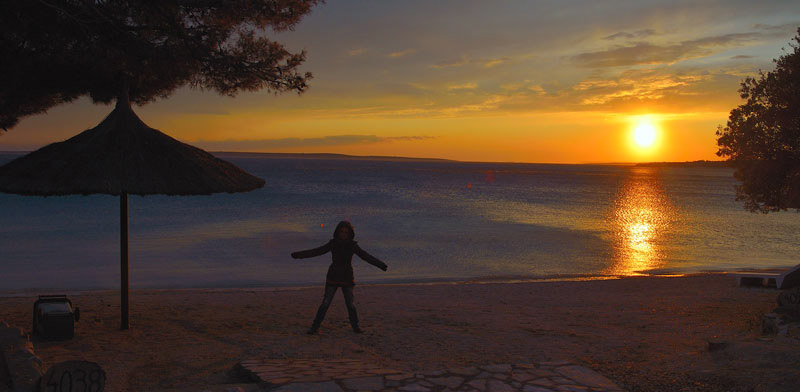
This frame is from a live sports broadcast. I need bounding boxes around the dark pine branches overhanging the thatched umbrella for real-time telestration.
[0,0,322,130]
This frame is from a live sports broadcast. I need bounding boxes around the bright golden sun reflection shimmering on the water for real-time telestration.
[607,167,676,275]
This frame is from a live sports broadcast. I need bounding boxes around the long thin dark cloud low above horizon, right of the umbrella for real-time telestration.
[194,135,435,151]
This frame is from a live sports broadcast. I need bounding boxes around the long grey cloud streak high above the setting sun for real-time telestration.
[572,32,764,68]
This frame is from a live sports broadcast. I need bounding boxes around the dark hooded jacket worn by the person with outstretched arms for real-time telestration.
[292,222,387,286]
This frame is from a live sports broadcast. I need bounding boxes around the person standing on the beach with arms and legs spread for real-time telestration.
[292,221,389,335]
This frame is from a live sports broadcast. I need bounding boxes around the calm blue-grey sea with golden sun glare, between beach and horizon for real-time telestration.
[0,156,800,290]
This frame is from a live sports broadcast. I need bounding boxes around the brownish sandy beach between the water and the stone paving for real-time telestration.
[0,275,800,391]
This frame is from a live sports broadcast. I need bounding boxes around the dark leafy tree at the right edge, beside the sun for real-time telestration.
[717,28,800,213]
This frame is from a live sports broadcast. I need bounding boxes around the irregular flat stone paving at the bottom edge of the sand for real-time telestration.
[240,360,622,392]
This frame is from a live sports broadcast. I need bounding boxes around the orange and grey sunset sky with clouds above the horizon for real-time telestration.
[0,0,800,163]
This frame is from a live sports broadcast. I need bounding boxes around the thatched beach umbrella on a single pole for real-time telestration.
[0,100,264,329]
